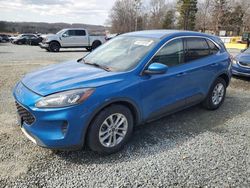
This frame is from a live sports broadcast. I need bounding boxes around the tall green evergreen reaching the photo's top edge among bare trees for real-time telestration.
[177,0,198,30]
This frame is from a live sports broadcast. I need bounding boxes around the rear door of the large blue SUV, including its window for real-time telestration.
[184,37,219,103]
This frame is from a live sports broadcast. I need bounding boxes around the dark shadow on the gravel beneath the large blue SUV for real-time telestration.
[55,93,250,164]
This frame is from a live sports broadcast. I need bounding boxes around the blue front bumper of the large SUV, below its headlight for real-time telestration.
[13,83,96,150]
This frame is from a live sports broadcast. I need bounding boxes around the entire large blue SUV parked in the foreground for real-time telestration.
[13,30,231,154]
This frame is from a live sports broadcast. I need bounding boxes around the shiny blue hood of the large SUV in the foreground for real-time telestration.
[22,61,122,96]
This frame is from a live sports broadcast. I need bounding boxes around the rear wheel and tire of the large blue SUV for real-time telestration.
[202,77,227,110]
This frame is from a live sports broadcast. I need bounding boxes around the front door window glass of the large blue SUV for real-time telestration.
[151,39,184,67]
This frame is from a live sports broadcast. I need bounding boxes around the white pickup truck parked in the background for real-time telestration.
[39,28,106,52]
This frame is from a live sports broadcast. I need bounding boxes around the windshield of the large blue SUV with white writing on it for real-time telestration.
[83,36,158,71]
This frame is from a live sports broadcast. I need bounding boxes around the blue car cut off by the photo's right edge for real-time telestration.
[232,48,250,77]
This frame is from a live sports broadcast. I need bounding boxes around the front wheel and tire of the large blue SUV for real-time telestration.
[87,105,134,154]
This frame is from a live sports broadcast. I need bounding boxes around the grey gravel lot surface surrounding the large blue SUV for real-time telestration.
[0,44,250,187]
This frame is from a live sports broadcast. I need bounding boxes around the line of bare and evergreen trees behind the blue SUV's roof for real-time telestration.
[107,0,250,35]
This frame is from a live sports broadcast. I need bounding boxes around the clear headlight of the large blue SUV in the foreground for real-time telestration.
[36,88,94,108]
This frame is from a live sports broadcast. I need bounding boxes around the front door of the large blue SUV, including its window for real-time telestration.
[141,39,196,119]
